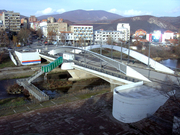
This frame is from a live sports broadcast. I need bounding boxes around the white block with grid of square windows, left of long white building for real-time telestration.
[69,25,93,45]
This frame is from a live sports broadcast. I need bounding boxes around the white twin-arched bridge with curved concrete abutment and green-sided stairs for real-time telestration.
[15,45,177,123]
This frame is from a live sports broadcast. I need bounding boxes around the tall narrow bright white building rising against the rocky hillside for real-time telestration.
[117,23,130,41]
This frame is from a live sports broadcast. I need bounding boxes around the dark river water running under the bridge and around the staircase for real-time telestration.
[0,72,110,99]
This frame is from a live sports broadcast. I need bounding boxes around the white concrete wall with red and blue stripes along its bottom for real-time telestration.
[15,51,41,65]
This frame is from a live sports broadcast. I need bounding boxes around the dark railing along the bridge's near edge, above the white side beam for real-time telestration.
[74,60,140,82]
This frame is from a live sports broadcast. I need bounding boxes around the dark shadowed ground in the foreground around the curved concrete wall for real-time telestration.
[0,92,180,135]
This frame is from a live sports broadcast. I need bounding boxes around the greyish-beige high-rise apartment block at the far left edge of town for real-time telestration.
[2,11,21,32]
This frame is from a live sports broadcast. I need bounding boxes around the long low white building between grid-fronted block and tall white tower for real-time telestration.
[94,29,125,44]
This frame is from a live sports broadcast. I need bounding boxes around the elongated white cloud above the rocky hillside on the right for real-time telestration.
[109,8,151,16]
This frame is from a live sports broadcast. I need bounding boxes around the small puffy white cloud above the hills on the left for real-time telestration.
[35,7,65,15]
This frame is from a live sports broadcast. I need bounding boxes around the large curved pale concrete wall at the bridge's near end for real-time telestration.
[112,82,168,123]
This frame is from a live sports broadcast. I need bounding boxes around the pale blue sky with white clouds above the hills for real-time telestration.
[0,0,180,17]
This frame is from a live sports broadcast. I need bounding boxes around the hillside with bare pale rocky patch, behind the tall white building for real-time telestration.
[90,16,178,33]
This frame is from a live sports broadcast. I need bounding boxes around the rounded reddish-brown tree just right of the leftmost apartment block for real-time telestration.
[18,28,30,44]
